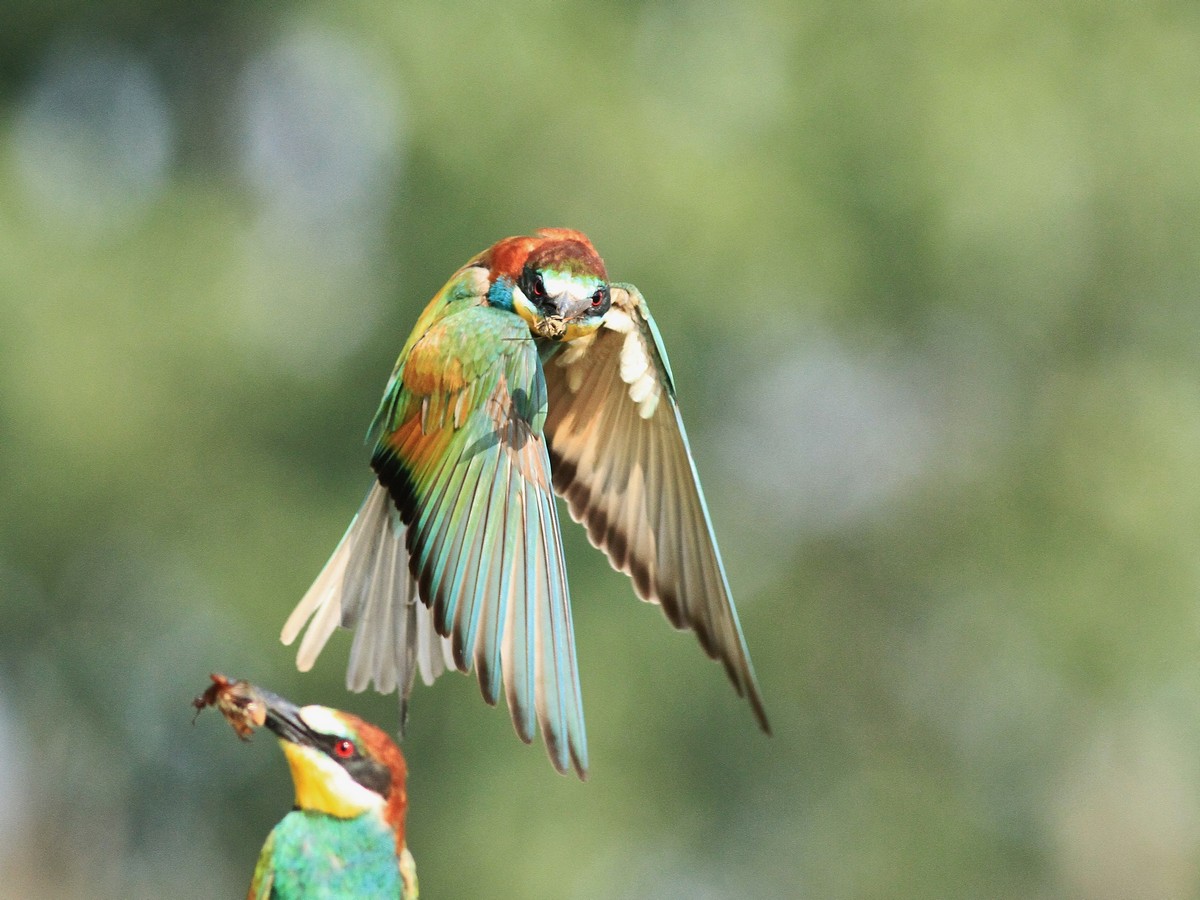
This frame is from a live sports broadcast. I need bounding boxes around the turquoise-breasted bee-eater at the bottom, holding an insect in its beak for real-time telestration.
[196,674,418,900]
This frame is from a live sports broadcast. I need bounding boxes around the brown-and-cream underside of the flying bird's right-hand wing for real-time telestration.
[546,284,770,733]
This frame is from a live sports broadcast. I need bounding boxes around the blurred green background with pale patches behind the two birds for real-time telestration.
[0,0,1200,900]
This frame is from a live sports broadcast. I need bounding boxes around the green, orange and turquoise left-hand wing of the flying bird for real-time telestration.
[372,306,587,775]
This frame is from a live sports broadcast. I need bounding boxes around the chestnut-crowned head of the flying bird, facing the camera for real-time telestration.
[472,228,612,341]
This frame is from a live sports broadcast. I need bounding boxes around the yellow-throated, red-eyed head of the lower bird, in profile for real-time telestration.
[260,691,408,850]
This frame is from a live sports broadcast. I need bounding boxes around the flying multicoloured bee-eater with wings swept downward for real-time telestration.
[282,228,770,778]
